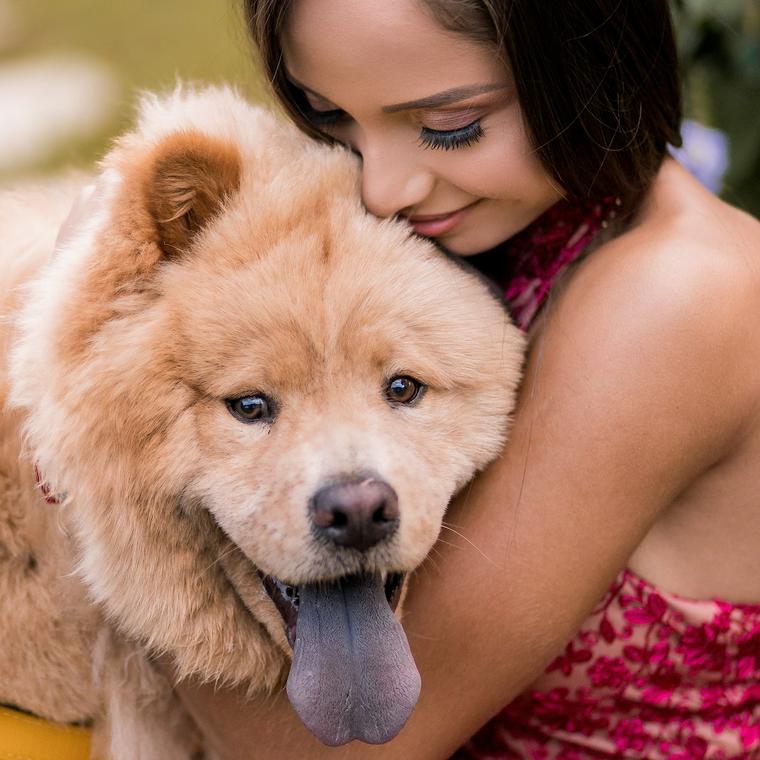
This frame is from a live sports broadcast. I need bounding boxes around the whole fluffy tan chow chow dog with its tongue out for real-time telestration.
[0,88,524,760]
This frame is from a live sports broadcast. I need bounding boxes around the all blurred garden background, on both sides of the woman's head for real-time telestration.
[0,0,760,216]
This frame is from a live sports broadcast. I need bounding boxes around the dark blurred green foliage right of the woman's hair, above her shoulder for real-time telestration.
[676,0,760,216]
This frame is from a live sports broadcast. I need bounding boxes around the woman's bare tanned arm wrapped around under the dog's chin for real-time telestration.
[171,227,754,760]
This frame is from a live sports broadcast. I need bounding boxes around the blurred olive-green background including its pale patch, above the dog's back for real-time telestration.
[0,0,265,182]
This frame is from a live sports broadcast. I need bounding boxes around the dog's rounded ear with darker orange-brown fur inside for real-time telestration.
[143,131,241,256]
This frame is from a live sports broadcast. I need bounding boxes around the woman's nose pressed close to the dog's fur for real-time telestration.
[360,142,435,218]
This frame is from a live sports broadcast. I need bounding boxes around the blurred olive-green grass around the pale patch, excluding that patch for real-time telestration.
[0,0,265,171]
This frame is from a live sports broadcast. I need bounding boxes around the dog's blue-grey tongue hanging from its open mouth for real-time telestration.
[287,576,420,747]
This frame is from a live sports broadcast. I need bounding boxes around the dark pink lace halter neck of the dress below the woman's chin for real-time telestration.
[500,196,621,330]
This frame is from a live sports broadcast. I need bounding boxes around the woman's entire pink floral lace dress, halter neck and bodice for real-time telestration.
[452,199,760,760]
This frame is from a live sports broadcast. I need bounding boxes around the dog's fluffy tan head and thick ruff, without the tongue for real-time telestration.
[13,90,523,744]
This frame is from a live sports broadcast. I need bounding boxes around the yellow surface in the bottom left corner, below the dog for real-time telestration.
[0,707,91,760]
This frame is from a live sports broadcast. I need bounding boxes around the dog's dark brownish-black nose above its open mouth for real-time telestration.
[310,478,399,551]
